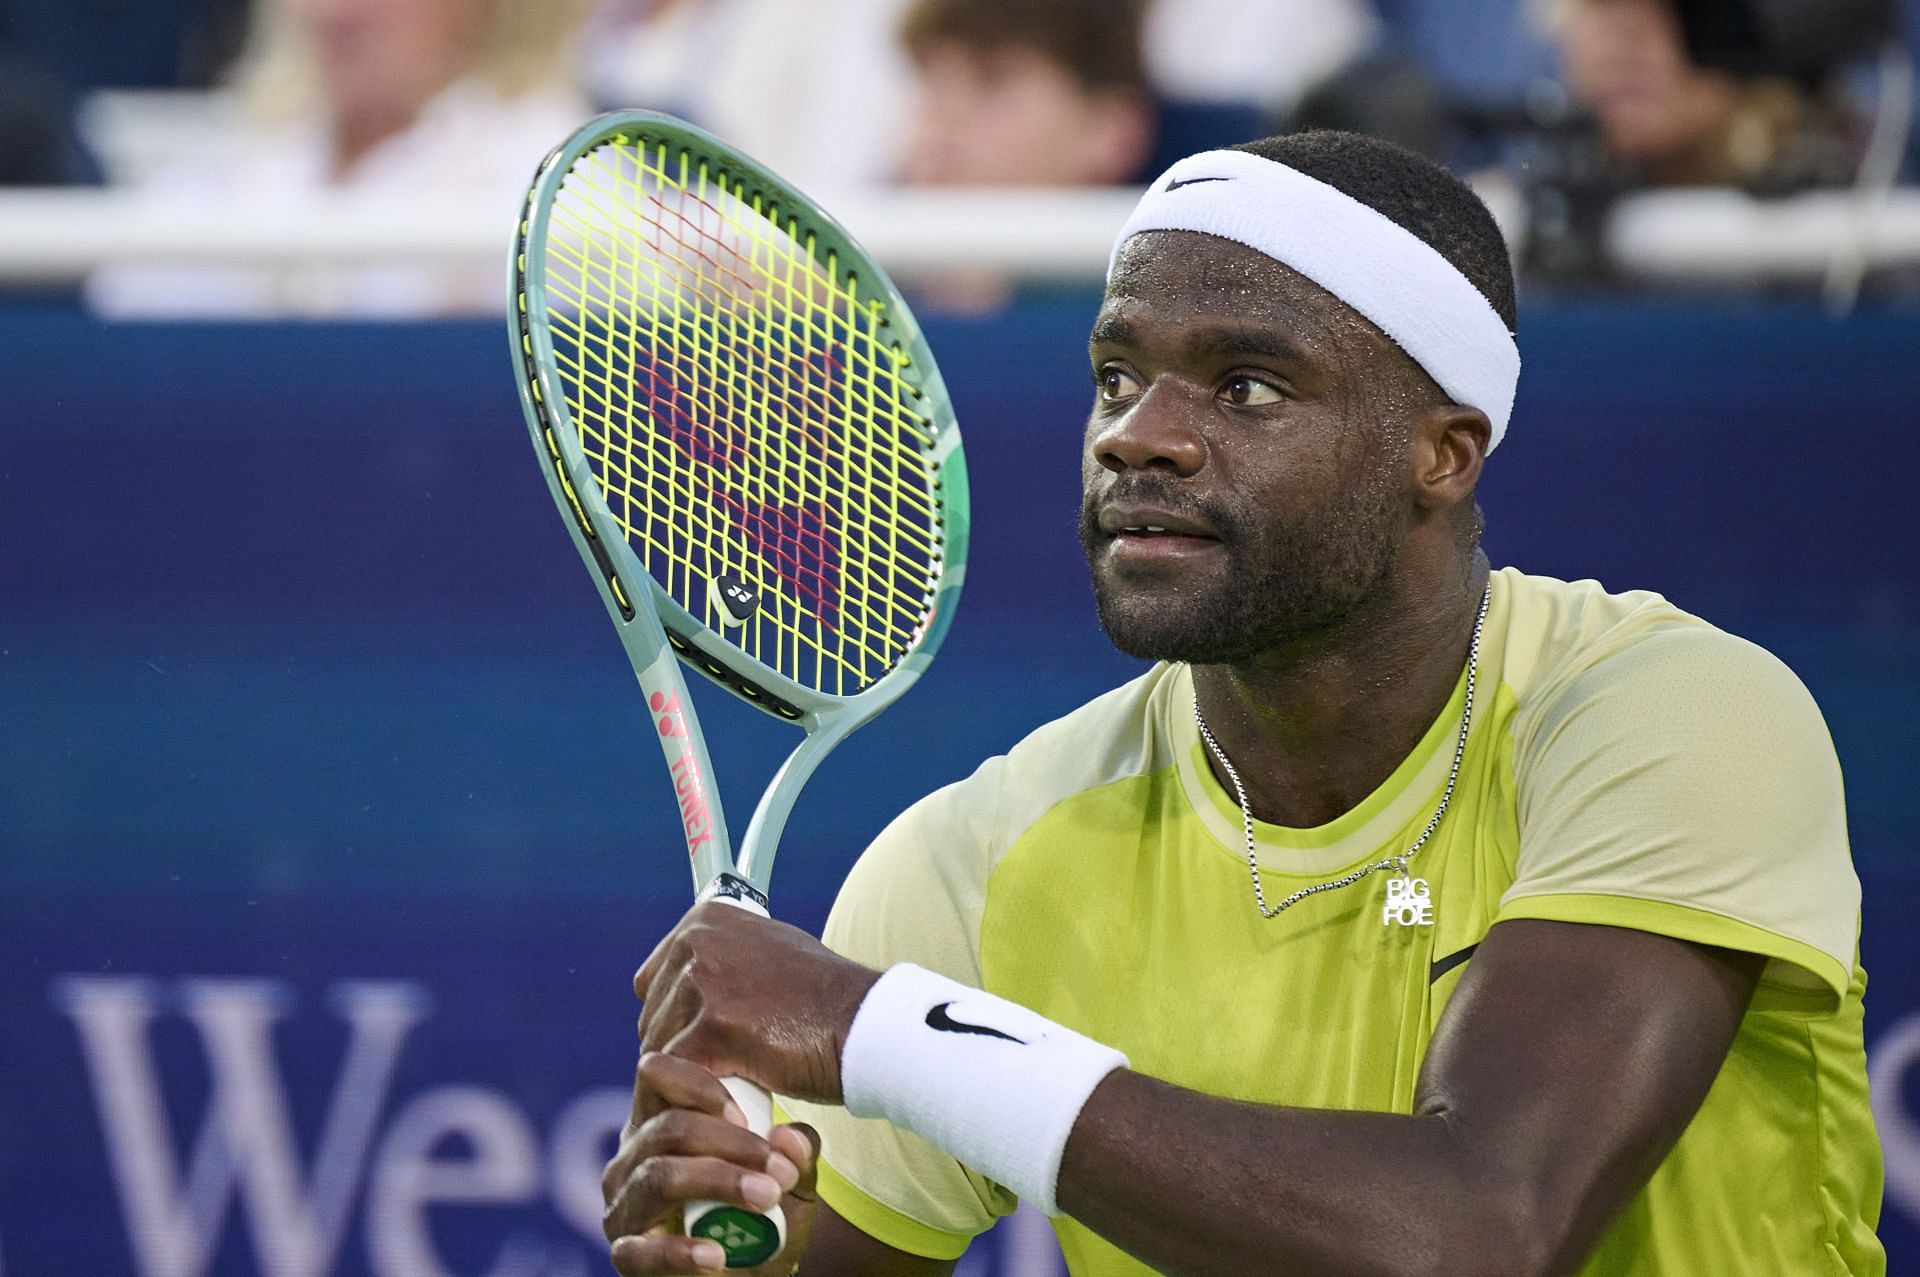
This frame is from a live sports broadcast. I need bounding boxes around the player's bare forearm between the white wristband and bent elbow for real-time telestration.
[1060,1072,1569,1277]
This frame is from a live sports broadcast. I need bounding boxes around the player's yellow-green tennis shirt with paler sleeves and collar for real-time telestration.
[787,568,1885,1277]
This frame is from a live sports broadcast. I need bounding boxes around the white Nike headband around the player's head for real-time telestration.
[1108,152,1521,451]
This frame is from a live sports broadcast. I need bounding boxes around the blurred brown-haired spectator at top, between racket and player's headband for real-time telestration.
[900,0,1154,186]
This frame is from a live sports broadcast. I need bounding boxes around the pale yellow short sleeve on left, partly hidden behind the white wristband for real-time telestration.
[781,759,1016,1260]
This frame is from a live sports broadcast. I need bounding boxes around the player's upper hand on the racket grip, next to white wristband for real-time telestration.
[634,903,879,1104]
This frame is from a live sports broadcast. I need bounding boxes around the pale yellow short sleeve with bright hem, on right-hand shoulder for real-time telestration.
[1500,624,1860,1010]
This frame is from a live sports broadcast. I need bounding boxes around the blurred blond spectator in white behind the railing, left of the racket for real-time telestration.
[88,0,589,317]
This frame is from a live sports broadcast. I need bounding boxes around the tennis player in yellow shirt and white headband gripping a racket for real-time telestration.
[607,134,1885,1277]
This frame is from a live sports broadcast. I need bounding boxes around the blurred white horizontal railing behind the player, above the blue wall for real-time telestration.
[0,188,1920,288]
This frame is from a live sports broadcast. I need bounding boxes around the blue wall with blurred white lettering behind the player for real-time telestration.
[0,298,1920,1277]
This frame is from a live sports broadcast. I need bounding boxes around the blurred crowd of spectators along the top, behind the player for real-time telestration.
[0,0,1920,317]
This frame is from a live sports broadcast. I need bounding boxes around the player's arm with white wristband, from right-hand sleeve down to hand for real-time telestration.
[636,904,1766,1277]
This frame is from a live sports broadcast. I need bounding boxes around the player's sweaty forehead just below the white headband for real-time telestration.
[1100,230,1405,361]
